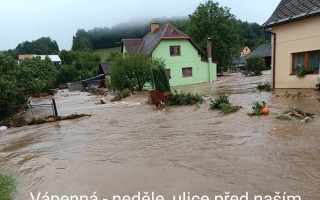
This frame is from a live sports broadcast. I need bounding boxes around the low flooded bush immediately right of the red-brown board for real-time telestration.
[167,90,203,105]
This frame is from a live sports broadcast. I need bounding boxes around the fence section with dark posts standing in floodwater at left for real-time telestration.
[27,99,58,118]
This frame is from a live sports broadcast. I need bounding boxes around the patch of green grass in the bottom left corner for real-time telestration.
[0,174,16,200]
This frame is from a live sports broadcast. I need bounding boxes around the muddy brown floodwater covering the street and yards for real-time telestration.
[0,73,320,200]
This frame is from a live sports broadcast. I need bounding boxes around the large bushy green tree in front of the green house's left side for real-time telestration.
[111,54,153,91]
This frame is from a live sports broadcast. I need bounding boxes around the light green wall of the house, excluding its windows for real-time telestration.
[152,40,217,86]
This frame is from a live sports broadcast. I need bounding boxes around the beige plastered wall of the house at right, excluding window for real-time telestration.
[272,16,320,88]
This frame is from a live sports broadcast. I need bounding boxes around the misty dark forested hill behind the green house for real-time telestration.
[72,17,270,51]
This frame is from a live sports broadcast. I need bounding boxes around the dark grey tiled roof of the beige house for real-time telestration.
[262,0,320,28]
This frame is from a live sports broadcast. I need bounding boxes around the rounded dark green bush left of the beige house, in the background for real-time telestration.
[245,56,266,76]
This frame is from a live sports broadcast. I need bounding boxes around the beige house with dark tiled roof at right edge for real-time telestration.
[262,0,320,88]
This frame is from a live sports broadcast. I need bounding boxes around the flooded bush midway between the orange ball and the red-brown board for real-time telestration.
[209,94,241,115]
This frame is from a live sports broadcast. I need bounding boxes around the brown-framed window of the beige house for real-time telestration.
[292,50,320,73]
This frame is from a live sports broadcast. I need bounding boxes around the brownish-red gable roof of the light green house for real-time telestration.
[122,23,204,54]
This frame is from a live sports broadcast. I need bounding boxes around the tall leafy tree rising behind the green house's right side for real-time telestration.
[188,0,242,73]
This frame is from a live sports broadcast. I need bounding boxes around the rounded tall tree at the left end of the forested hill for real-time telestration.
[72,29,93,51]
